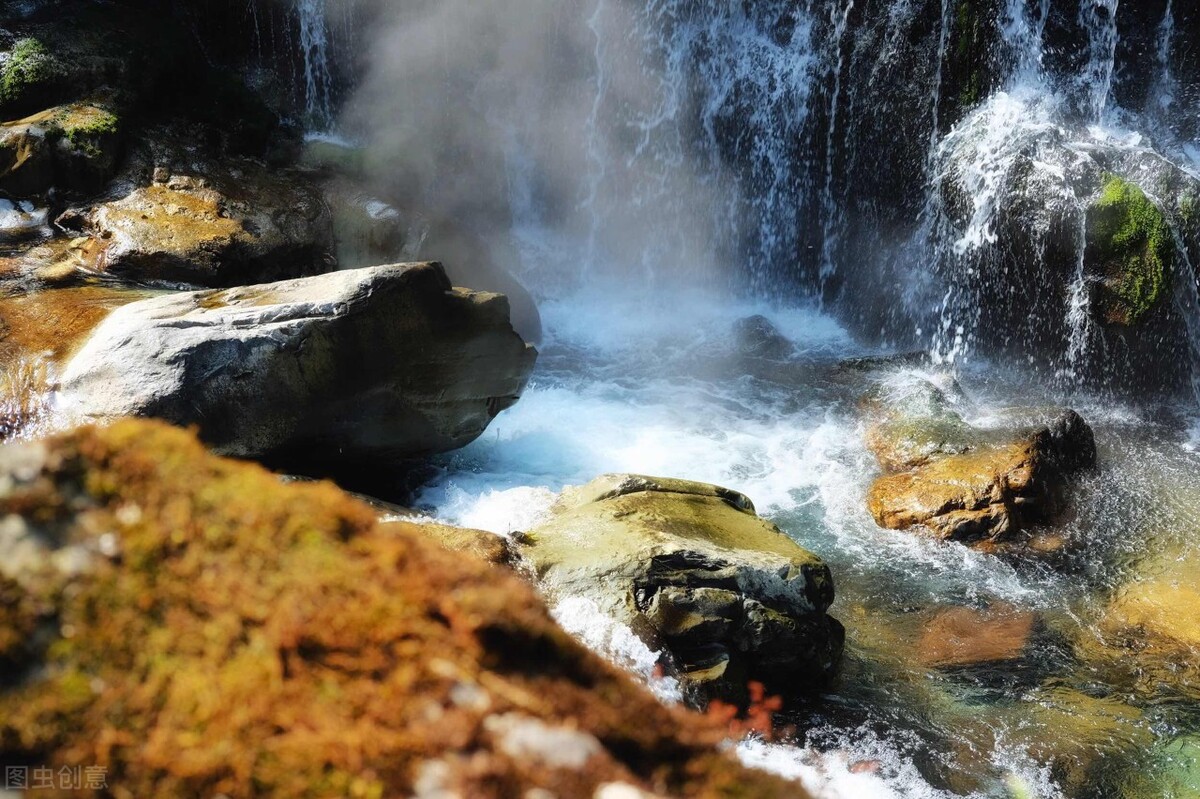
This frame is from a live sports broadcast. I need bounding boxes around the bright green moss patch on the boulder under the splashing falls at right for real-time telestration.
[1087,175,1175,325]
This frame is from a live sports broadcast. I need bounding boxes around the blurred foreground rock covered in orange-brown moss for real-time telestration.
[0,421,805,798]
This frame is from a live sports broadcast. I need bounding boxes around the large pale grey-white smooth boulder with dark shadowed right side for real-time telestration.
[58,263,536,470]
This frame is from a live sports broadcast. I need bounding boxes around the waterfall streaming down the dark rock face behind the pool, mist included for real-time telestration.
[343,0,1200,395]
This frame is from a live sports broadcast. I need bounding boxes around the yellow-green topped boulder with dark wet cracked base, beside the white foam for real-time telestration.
[518,475,844,692]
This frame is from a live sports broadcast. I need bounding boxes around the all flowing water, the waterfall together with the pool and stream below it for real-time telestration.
[333,0,1200,798]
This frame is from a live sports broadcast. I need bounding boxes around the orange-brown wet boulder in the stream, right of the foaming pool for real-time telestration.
[866,378,1096,549]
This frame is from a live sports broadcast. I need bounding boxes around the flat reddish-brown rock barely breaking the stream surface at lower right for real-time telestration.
[917,605,1037,669]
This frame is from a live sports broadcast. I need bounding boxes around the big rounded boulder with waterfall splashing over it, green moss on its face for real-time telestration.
[937,94,1200,392]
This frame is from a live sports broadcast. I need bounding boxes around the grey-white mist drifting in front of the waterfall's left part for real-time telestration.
[340,0,738,298]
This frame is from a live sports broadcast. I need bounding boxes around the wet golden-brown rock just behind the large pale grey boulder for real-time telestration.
[70,161,332,287]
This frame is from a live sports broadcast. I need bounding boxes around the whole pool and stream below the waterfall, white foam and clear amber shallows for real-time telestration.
[418,287,1200,797]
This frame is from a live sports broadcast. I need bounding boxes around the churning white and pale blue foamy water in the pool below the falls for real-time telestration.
[418,272,1183,798]
